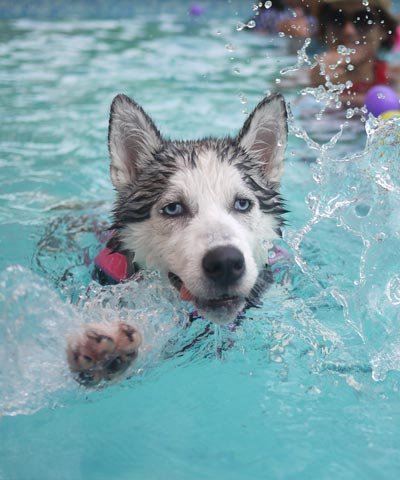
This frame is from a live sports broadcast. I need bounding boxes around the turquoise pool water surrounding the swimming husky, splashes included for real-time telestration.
[0,1,400,480]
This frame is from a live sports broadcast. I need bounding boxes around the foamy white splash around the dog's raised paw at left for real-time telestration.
[0,266,187,415]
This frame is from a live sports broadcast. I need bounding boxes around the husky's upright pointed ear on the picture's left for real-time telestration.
[108,94,162,190]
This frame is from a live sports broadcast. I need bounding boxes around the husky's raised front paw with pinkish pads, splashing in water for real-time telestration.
[67,322,142,387]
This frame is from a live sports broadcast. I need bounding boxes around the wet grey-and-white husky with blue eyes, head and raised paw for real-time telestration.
[67,94,287,385]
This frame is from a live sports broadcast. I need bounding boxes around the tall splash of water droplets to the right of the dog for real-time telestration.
[287,110,400,379]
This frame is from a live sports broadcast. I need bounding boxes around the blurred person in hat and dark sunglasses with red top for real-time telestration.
[311,0,397,107]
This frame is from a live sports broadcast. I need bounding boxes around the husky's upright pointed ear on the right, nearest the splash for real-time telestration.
[237,94,288,183]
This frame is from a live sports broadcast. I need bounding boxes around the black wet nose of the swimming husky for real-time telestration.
[203,245,246,286]
